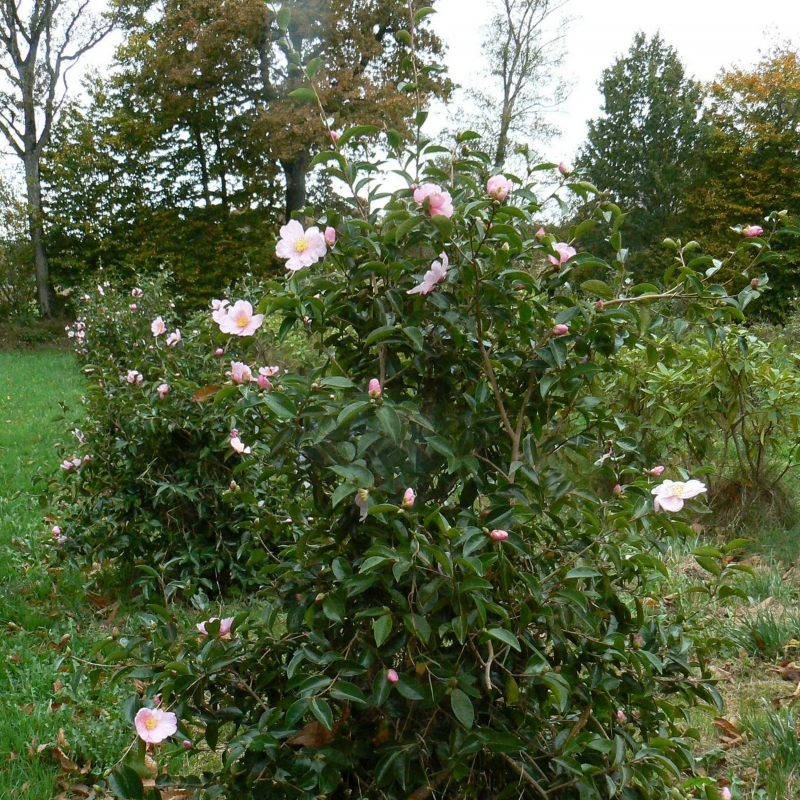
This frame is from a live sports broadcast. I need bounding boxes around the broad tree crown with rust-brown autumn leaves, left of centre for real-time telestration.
[112,0,448,216]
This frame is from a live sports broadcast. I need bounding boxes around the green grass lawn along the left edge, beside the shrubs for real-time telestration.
[0,351,130,800]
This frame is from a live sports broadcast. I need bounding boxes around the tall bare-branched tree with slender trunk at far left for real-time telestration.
[0,0,111,316]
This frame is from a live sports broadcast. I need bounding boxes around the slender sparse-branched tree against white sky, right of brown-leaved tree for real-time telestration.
[459,0,568,168]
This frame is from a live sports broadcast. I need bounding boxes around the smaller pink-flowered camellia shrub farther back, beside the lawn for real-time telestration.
[49,277,313,602]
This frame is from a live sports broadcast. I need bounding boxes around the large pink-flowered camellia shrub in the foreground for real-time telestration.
[76,112,788,800]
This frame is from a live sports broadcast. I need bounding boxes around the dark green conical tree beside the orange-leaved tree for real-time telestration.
[578,33,701,268]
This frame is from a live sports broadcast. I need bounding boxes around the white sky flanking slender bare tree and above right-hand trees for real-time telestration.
[432,0,800,163]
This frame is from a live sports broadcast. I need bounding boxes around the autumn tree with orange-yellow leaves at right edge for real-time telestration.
[679,45,800,320]
